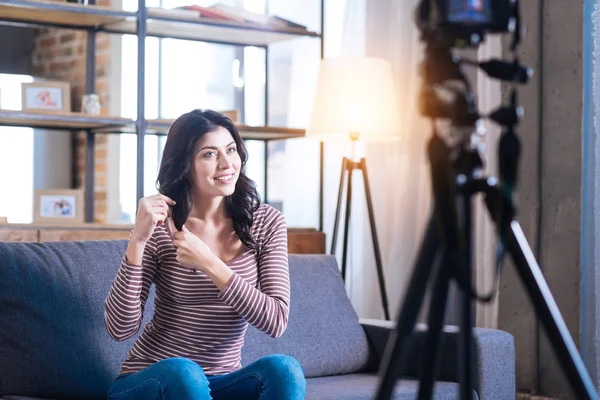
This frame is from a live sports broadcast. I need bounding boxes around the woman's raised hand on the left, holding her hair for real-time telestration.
[131,194,175,244]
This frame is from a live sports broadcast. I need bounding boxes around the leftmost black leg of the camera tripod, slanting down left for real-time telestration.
[375,216,441,400]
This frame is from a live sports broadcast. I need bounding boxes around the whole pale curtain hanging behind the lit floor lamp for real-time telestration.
[324,0,430,318]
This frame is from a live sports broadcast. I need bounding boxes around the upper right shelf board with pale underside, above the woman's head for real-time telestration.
[104,8,320,46]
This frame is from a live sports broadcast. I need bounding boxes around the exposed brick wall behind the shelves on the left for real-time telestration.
[33,0,110,222]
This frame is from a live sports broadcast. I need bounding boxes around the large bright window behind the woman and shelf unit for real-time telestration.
[119,0,320,227]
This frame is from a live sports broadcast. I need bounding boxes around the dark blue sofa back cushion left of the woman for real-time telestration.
[0,241,153,398]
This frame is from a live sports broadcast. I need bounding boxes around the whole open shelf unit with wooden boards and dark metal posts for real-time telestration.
[0,0,324,229]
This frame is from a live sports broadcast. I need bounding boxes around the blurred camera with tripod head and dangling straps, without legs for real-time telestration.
[415,0,533,142]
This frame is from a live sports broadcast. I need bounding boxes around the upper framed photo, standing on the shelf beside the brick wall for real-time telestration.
[21,81,71,113]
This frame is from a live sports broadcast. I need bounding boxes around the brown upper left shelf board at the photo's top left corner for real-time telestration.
[0,0,136,28]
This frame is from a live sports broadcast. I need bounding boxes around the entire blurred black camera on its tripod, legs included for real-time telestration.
[375,0,598,400]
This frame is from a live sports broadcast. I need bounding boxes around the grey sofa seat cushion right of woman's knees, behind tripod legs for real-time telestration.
[305,374,479,400]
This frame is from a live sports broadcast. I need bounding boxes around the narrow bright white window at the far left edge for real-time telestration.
[0,74,34,223]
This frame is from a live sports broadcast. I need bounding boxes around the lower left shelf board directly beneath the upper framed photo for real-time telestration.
[0,110,133,132]
